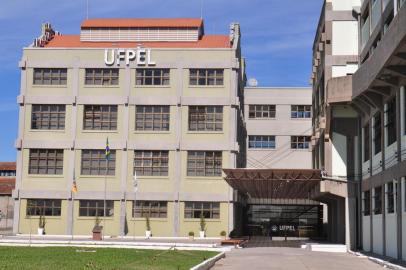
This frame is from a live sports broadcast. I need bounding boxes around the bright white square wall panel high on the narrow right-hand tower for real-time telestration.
[332,21,358,55]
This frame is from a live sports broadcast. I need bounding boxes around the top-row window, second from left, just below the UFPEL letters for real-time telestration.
[85,68,119,85]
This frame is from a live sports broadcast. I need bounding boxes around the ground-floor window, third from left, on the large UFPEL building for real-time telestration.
[133,201,168,218]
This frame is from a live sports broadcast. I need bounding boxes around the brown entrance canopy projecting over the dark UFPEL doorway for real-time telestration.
[223,169,321,199]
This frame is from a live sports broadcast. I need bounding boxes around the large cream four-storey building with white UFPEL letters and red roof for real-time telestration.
[13,19,245,237]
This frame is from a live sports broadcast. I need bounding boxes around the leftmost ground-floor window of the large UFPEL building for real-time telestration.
[26,199,61,216]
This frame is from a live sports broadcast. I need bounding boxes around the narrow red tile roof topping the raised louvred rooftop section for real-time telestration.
[81,18,203,28]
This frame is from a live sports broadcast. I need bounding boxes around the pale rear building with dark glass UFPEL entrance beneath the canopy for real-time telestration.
[242,87,323,237]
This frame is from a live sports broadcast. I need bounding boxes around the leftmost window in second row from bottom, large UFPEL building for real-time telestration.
[28,149,63,175]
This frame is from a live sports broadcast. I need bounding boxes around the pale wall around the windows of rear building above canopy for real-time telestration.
[244,87,312,169]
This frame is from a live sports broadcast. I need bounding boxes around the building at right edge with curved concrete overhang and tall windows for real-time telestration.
[352,0,406,261]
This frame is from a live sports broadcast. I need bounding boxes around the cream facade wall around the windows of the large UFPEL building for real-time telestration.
[15,25,244,236]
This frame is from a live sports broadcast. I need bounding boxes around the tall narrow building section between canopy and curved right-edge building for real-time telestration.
[310,0,361,247]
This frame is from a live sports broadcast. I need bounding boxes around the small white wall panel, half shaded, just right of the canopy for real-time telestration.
[331,132,347,176]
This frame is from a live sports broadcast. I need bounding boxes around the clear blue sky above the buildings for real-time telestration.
[0,0,323,161]
